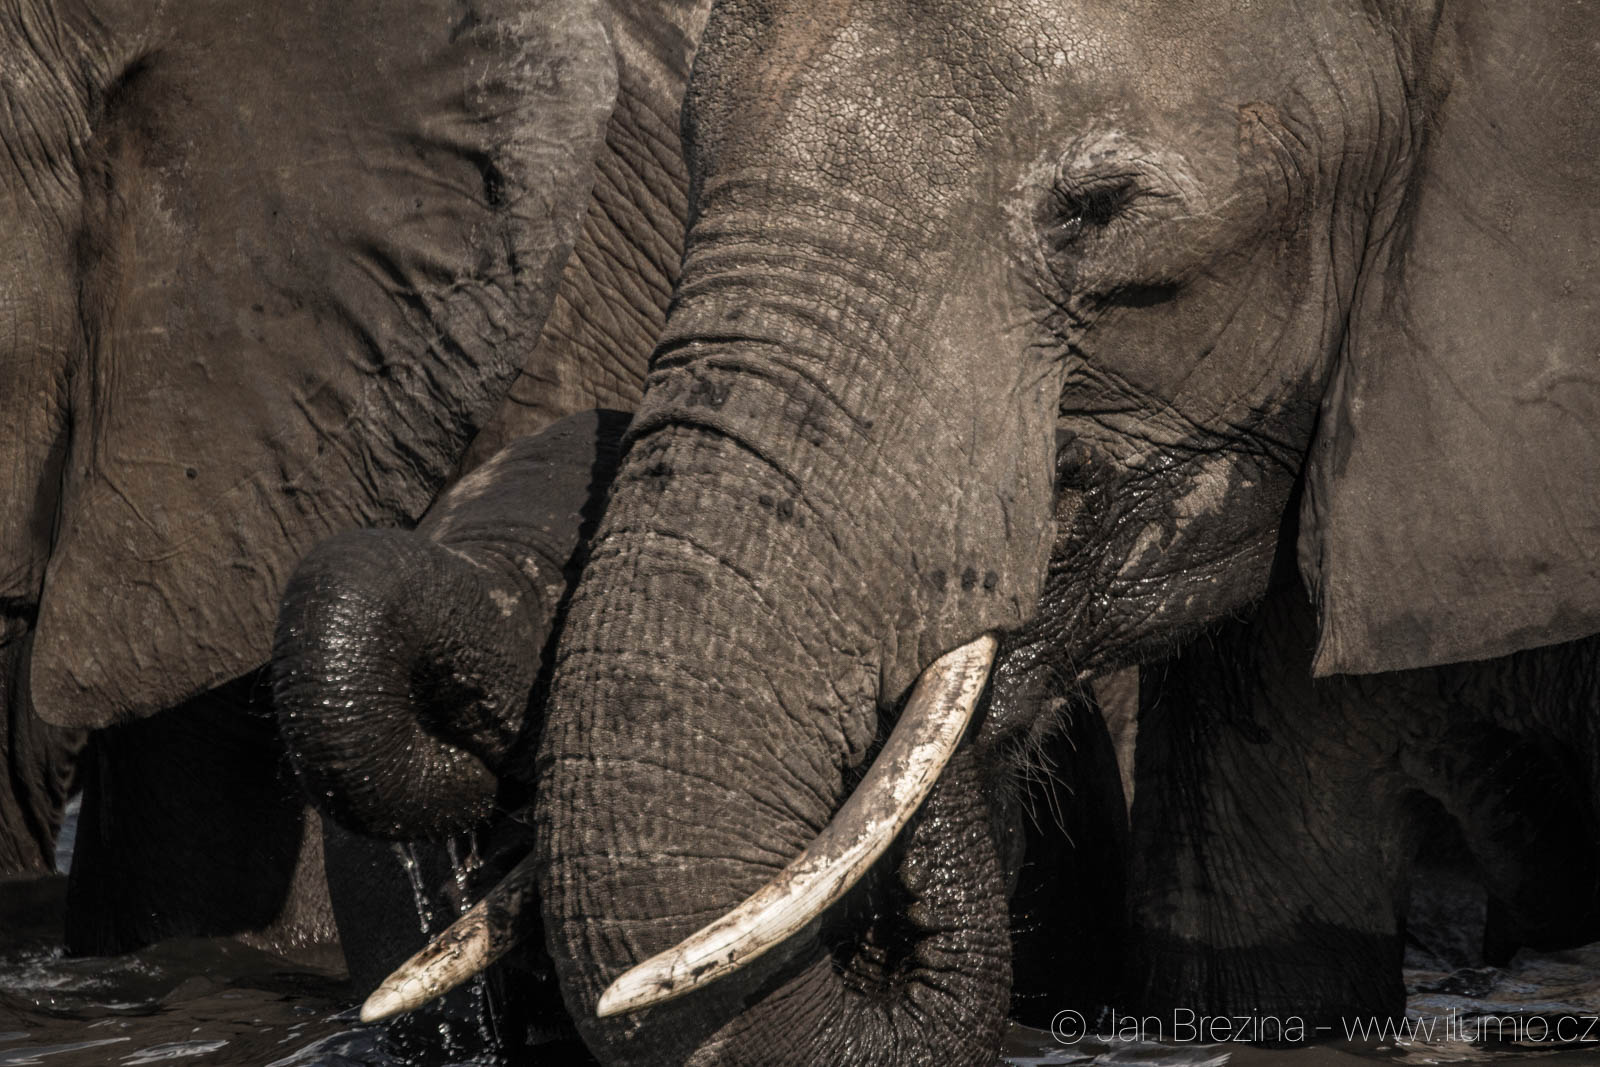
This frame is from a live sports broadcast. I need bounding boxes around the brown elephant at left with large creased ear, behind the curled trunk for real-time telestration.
[0,0,704,968]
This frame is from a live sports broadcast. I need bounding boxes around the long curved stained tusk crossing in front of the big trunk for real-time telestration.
[595,635,995,1017]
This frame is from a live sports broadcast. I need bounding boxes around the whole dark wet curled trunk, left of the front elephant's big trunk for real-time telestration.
[272,411,627,840]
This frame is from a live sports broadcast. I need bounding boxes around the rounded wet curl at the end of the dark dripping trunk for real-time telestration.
[272,530,549,840]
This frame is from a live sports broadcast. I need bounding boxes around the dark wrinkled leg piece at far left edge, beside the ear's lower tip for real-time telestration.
[0,641,86,878]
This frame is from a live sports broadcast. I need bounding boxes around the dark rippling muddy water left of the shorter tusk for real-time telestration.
[0,808,510,1067]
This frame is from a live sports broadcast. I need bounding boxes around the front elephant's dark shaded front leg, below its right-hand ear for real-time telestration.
[1128,585,1414,1040]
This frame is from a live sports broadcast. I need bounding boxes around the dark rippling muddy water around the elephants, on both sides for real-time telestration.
[9,806,1600,1067]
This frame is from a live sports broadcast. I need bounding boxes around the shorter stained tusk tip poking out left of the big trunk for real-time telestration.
[362,856,534,1022]
